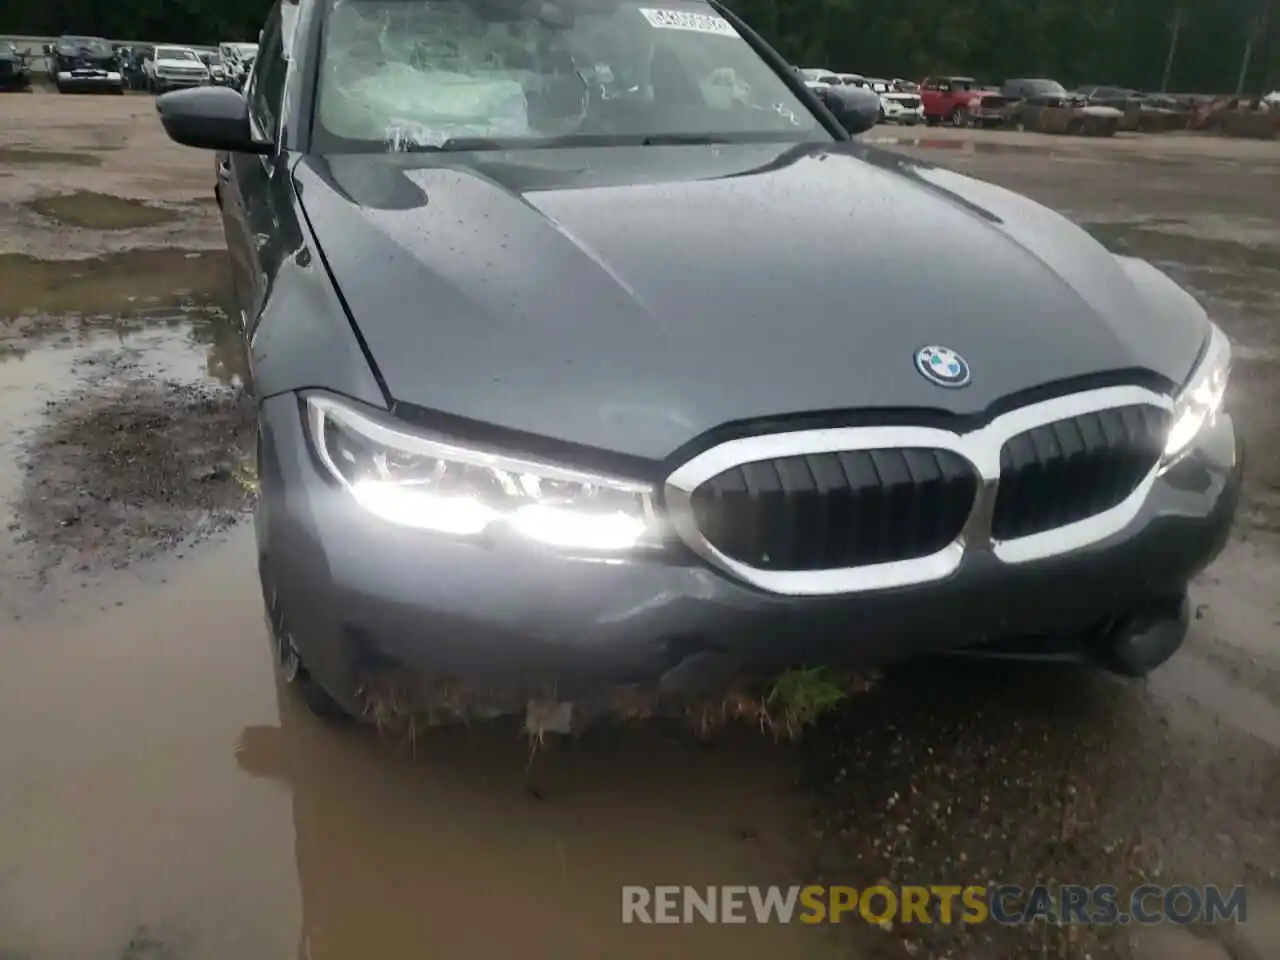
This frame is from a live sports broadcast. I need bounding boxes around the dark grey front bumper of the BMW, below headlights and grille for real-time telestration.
[256,396,1243,707]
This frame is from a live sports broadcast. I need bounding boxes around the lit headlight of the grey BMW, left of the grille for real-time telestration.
[306,396,662,552]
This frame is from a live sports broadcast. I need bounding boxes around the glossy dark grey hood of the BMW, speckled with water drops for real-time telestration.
[293,142,1204,460]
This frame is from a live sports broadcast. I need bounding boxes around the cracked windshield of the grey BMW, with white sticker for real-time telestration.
[315,0,831,152]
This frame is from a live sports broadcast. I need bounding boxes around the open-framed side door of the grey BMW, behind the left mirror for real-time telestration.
[218,0,288,353]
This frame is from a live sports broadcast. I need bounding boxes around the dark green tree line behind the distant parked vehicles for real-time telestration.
[0,0,1280,93]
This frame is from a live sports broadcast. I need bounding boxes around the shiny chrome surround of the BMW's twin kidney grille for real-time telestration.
[663,387,1174,596]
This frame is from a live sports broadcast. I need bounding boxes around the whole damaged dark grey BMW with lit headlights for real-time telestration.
[156,0,1243,730]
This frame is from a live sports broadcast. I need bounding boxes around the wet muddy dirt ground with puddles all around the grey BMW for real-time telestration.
[0,93,1280,960]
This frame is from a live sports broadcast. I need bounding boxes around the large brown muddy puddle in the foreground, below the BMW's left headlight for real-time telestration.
[0,530,836,960]
